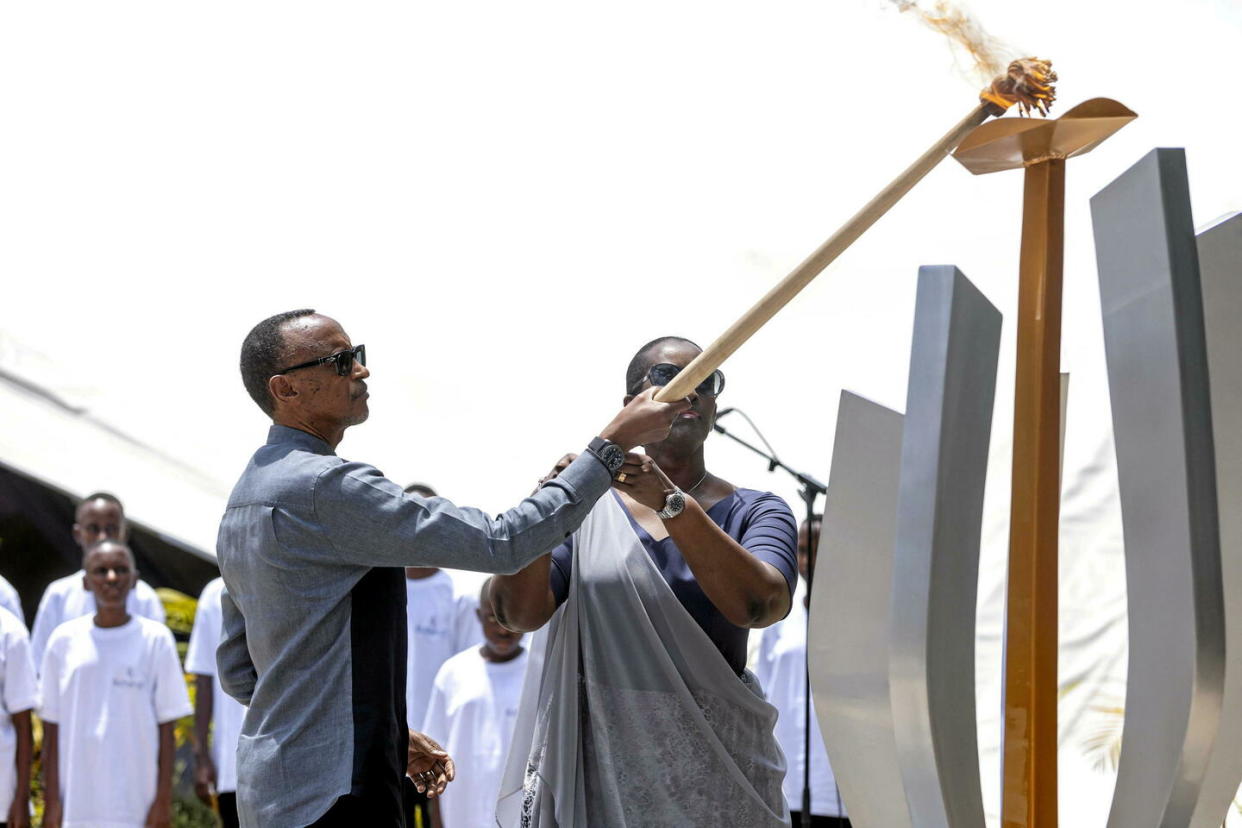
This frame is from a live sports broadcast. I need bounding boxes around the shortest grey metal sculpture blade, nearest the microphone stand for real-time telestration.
[809,391,910,828]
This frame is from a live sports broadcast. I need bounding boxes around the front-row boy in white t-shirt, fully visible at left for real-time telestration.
[40,540,193,828]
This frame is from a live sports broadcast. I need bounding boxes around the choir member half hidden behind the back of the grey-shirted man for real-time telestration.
[185,578,246,828]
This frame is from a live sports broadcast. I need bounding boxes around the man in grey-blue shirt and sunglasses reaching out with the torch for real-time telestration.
[216,310,688,828]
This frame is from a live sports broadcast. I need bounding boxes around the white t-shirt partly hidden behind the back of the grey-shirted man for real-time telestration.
[185,578,246,793]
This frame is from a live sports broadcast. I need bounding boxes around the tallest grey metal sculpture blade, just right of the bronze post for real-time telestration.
[1090,149,1225,828]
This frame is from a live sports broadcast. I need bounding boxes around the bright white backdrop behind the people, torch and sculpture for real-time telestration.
[0,0,1242,826]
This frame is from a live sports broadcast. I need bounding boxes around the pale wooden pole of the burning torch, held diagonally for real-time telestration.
[656,102,999,402]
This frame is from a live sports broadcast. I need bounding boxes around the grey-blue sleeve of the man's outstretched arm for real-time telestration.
[314,453,611,574]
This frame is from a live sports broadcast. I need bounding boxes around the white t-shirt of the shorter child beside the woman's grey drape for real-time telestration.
[422,647,527,828]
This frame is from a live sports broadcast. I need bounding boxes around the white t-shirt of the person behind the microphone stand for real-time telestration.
[755,593,846,817]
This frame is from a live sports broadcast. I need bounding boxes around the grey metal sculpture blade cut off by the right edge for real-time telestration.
[1190,214,1242,828]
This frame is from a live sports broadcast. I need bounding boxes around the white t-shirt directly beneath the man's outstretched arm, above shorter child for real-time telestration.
[405,570,483,730]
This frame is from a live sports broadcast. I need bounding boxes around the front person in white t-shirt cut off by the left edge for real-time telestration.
[0,607,39,828]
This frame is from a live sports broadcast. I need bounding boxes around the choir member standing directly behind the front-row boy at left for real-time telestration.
[30,492,164,668]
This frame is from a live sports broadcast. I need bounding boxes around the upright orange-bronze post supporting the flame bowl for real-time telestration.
[1001,159,1066,828]
